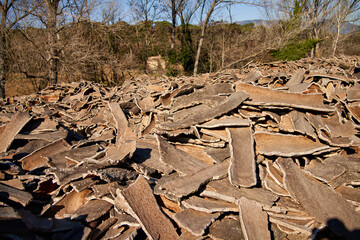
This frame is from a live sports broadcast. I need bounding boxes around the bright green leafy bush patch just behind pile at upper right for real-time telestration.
[271,39,322,61]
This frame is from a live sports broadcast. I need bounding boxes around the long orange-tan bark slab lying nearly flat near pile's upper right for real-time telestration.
[236,83,334,112]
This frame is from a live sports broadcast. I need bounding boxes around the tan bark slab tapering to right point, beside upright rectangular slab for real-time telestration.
[254,132,330,157]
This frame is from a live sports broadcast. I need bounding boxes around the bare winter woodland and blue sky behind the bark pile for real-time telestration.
[0,0,360,98]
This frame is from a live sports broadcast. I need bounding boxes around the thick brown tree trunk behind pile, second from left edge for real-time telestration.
[46,0,59,85]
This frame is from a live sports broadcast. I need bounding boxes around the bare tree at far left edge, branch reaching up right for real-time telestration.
[0,0,38,98]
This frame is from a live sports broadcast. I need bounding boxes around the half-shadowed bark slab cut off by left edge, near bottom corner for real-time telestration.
[0,183,33,207]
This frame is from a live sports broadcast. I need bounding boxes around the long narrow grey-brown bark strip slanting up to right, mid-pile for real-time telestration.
[160,92,248,130]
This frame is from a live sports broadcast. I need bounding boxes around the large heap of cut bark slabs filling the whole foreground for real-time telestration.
[0,58,360,239]
